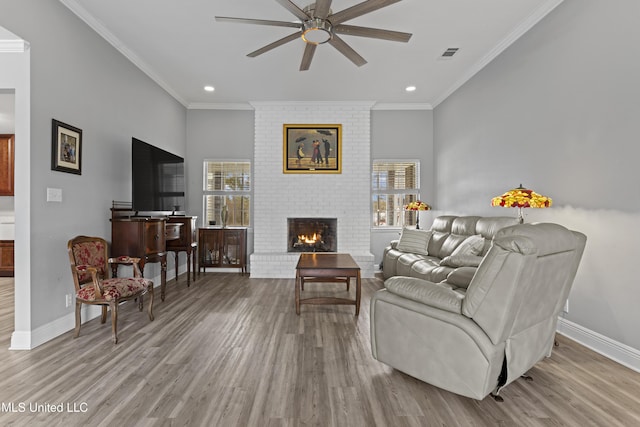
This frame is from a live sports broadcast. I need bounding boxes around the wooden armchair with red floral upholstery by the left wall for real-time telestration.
[67,236,153,344]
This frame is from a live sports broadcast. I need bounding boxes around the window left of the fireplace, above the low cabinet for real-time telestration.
[204,160,251,227]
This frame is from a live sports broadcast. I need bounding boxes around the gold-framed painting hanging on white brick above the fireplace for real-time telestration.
[282,124,342,173]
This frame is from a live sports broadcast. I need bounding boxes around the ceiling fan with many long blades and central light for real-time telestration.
[216,0,411,71]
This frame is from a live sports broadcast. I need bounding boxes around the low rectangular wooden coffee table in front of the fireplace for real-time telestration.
[296,253,361,316]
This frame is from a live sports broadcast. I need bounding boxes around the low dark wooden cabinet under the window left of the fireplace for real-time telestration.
[198,227,247,274]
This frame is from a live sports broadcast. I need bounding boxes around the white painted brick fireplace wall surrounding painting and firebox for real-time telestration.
[251,102,374,278]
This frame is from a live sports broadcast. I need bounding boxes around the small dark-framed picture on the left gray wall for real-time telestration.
[51,119,82,175]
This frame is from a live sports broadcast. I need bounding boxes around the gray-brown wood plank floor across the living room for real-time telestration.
[0,272,640,427]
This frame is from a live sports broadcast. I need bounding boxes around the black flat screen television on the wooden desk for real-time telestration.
[131,138,185,213]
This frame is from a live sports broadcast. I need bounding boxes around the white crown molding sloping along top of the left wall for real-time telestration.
[60,0,188,107]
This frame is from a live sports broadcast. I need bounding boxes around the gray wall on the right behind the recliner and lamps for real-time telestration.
[434,0,640,349]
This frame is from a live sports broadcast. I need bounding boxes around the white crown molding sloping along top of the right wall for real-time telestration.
[433,0,564,108]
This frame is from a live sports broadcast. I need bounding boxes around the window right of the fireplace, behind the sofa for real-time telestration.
[372,160,420,227]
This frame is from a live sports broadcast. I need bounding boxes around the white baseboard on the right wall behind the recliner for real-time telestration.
[557,318,640,372]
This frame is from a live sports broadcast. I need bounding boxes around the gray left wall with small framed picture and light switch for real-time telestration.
[0,0,186,329]
